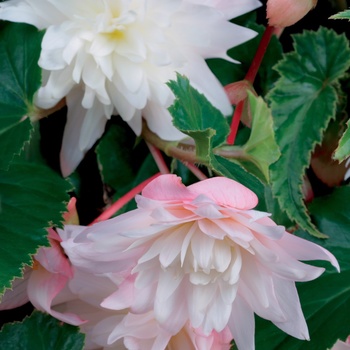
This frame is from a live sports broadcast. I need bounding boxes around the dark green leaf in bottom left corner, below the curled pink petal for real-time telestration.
[0,311,85,350]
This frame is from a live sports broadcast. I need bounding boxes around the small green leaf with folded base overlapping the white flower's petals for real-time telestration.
[167,74,229,163]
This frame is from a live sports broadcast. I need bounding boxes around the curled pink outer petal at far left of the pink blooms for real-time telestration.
[28,265,86,326]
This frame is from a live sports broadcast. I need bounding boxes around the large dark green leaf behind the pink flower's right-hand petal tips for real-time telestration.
[256,186,350,350]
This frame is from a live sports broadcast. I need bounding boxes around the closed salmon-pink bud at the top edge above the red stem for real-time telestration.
[266,0,317,28]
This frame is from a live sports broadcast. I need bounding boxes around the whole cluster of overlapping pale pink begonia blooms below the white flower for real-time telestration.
[2,175,339,350]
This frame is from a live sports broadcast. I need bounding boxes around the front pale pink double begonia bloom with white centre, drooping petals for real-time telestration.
[60,175,339,350]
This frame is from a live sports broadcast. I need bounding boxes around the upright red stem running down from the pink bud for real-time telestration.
[226,25,275,145]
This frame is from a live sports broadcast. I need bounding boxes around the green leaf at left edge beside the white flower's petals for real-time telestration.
[0,22,43,169]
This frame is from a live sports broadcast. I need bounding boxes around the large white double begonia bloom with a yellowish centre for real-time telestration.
[0,0,261,176]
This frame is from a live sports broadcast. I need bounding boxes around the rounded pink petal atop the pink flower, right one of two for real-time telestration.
[188,176,258,210]
